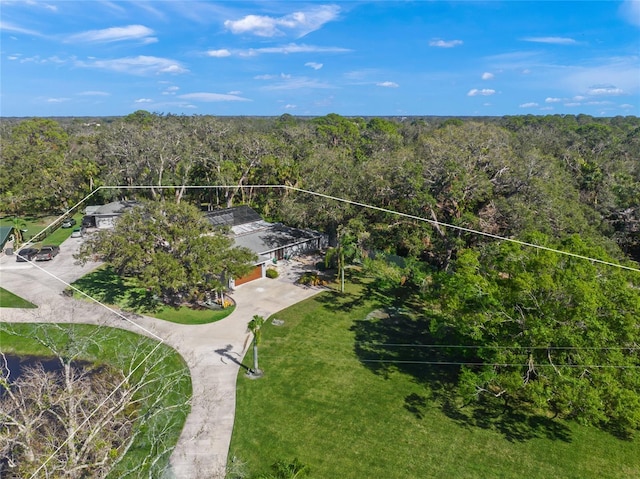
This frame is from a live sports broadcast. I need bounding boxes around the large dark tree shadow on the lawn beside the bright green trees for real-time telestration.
[351,306,571,442]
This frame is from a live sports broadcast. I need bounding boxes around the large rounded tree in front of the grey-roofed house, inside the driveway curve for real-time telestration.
[79,201,256,304]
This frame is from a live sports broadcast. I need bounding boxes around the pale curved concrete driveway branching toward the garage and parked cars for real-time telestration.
[0,238,321,479]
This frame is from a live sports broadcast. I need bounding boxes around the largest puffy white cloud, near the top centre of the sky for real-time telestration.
[224,5,340,38]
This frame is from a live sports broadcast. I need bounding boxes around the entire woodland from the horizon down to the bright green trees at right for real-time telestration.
[0,111,640,435]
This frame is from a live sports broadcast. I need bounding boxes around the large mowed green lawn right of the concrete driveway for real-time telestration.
[229,285,640,479]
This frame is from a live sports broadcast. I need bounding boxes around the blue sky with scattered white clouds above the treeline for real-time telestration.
[0,0,640,116]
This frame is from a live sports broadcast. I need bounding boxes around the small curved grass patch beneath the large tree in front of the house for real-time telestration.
[73,267,235,324]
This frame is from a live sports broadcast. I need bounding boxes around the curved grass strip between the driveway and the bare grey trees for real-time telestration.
[0,323,192,479]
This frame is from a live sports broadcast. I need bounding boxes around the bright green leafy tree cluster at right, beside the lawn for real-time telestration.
[431,236,640,433]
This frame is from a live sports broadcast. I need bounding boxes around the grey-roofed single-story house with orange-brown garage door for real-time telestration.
[205,206,327,287]
